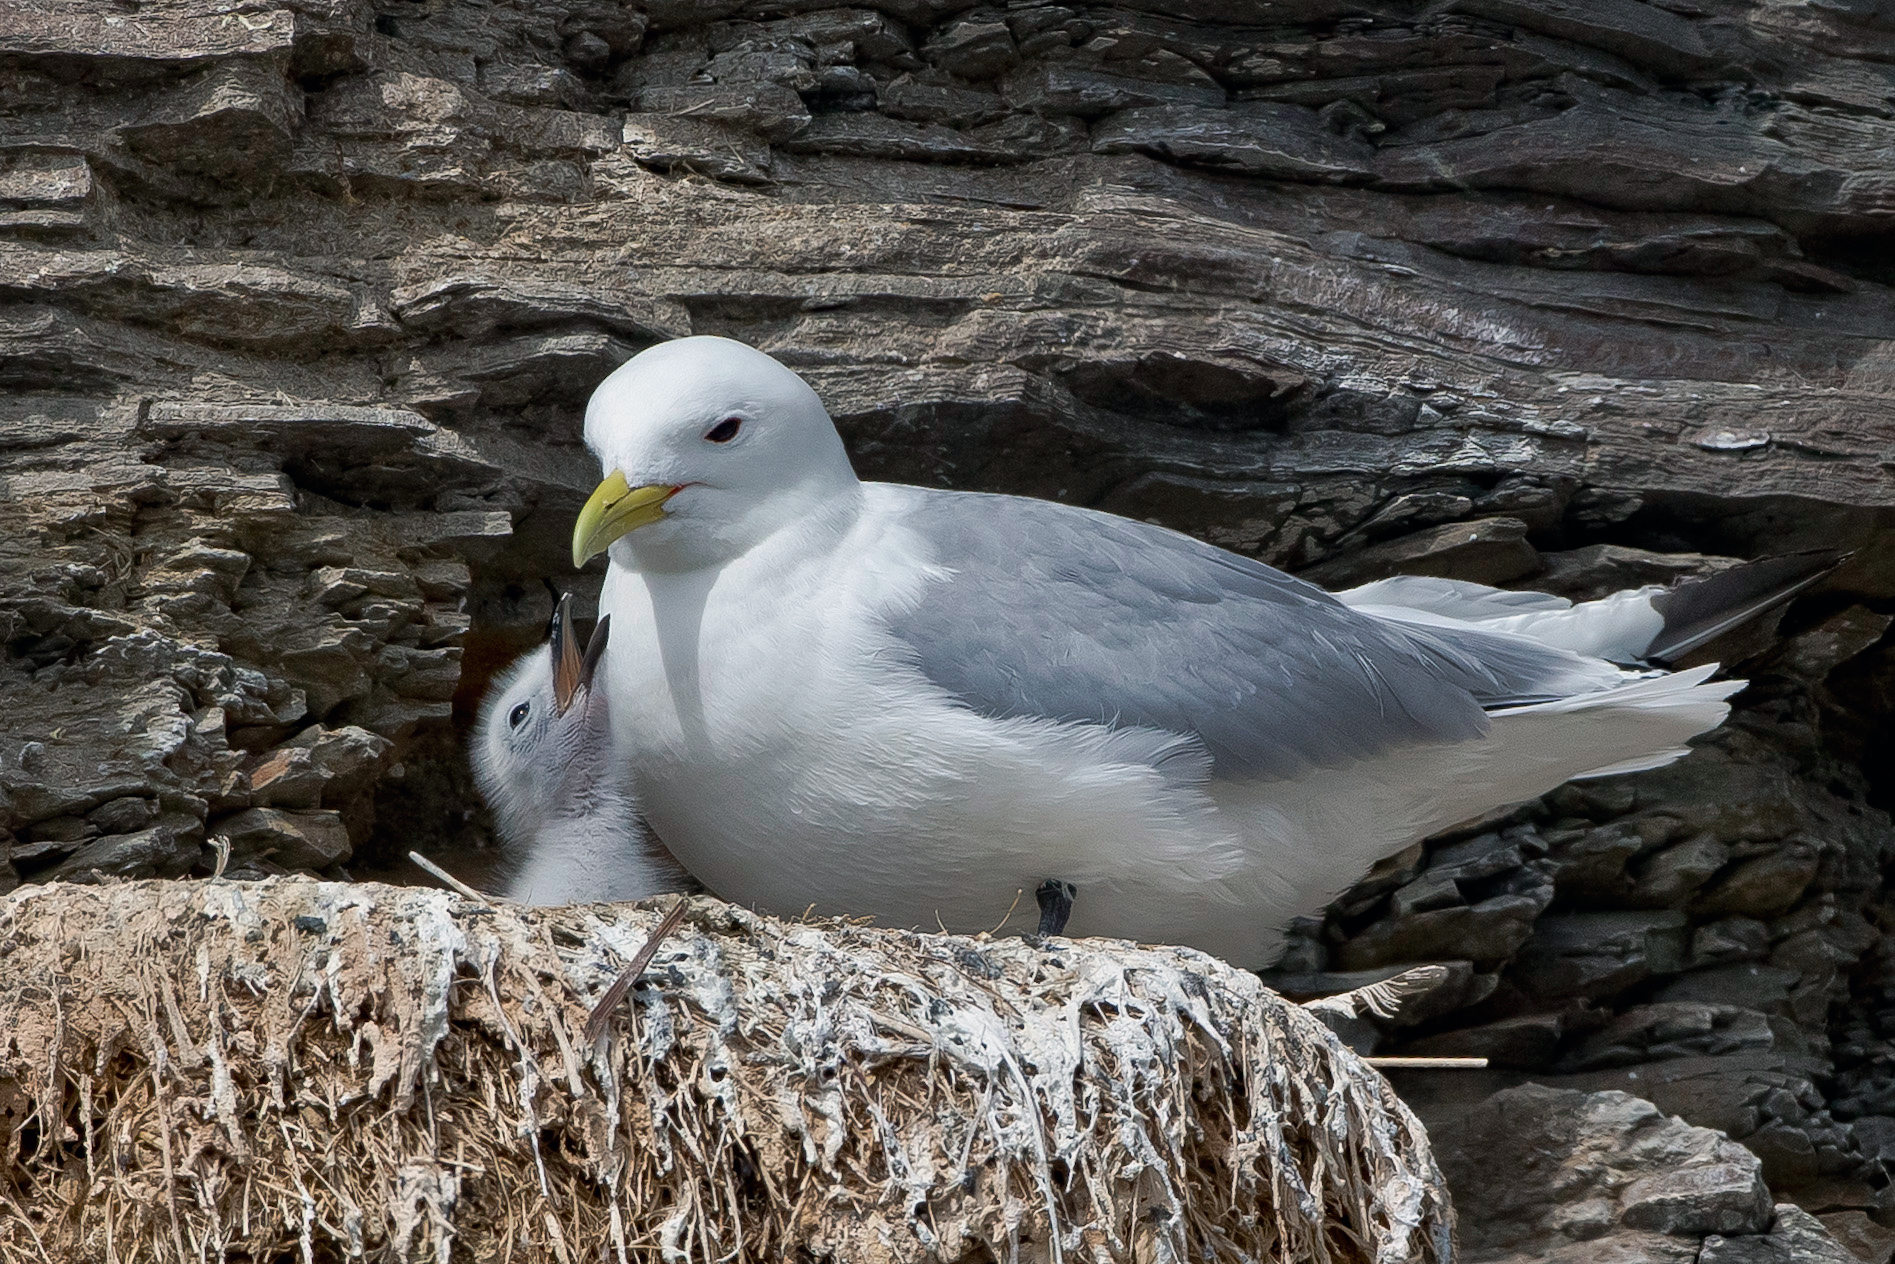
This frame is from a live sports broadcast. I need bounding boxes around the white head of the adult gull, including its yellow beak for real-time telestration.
[572,337,860,570]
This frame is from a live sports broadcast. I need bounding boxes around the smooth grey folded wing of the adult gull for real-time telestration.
[889,489,1601,779]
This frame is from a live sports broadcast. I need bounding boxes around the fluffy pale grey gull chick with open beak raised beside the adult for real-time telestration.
[474,593,694,904]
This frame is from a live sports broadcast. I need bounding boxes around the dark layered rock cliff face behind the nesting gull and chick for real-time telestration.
[0,0,1895,1249]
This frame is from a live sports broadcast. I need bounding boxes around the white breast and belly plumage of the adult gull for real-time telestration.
[603,500,1241,938]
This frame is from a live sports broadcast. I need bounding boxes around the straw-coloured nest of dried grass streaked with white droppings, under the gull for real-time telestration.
[0,879,1452,1264]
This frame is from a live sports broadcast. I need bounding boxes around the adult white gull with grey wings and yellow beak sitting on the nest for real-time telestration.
[572,337,1796,966]
